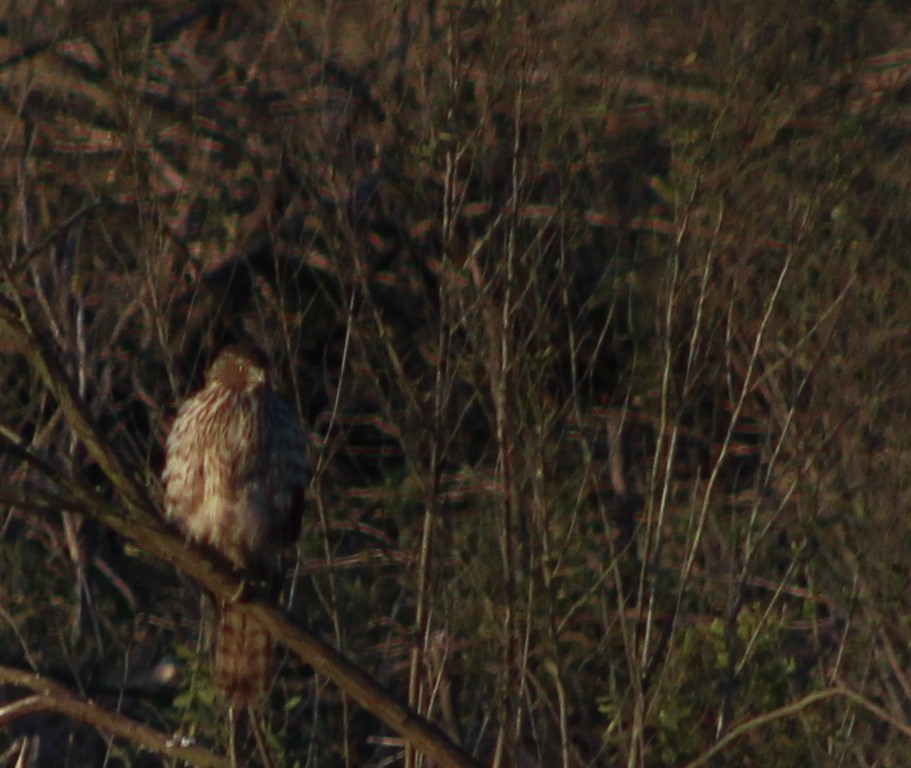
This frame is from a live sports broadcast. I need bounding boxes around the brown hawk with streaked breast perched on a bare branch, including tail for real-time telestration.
[162,347,308,707]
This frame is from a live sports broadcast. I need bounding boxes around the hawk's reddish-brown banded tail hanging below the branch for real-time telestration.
[215,605,272,707]
